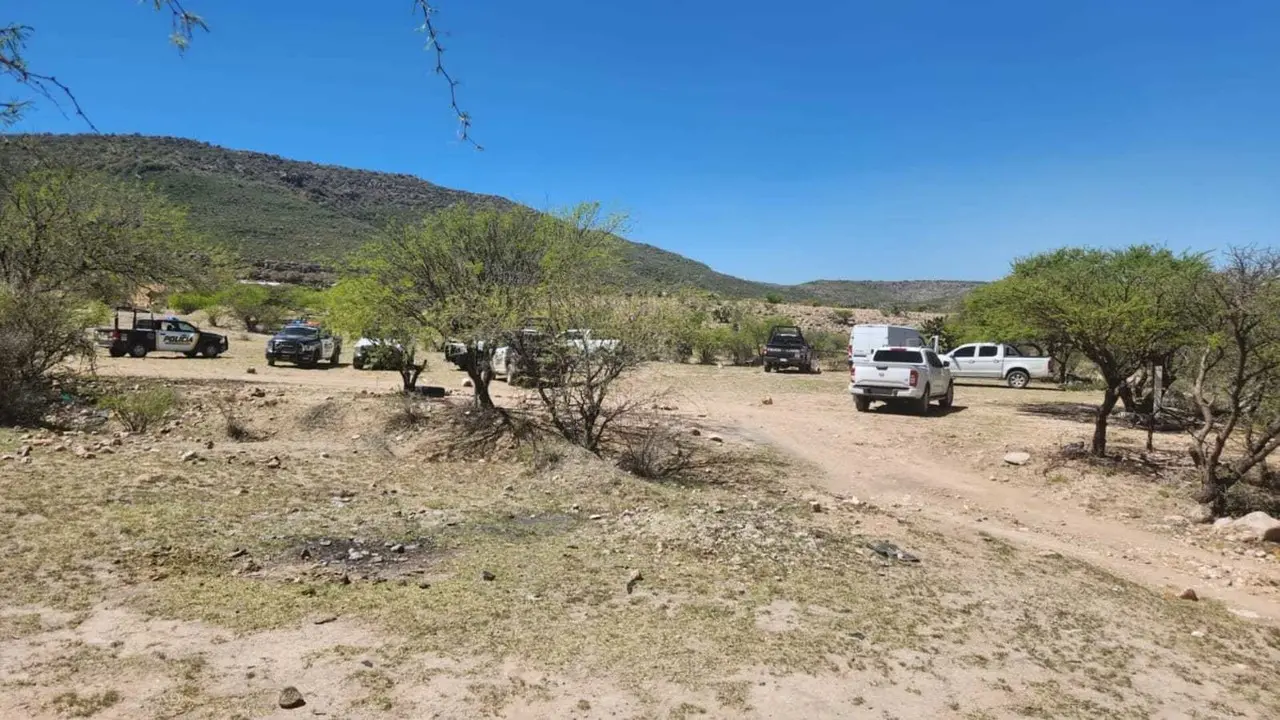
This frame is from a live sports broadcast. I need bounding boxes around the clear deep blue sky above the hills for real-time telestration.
[10,0,1280,282]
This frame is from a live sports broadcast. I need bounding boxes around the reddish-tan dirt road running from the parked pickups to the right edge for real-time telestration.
[659,369,1280,623]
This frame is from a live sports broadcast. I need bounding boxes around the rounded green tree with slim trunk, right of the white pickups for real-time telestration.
[965,245,1208,456]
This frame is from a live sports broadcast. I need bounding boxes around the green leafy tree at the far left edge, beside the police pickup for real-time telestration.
[0,169,199,424]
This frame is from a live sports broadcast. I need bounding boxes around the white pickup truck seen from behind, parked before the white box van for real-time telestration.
[849,347,955,415]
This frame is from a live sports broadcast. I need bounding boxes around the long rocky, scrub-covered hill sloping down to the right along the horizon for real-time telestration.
[0,135,978,309]
